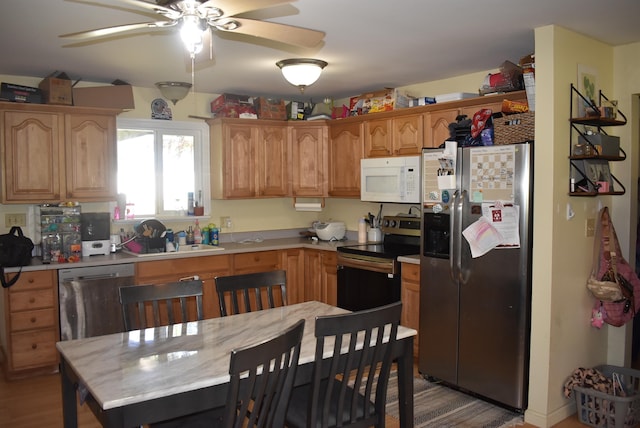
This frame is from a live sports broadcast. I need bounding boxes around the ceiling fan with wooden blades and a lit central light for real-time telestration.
[60,0,324,59]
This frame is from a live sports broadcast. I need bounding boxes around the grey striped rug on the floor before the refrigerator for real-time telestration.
[386,371,524,428]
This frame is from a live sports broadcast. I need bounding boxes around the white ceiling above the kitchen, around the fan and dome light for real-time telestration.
[0,0,640,101]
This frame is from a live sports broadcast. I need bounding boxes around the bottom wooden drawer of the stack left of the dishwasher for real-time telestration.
[11,329,58,370]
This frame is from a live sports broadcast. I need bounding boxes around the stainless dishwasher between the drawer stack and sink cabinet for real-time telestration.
[58,263,135,340]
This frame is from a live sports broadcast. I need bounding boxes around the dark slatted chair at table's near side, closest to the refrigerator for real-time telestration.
[286,302,402,428]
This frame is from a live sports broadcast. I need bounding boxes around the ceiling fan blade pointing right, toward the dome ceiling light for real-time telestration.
[216,17,324,48]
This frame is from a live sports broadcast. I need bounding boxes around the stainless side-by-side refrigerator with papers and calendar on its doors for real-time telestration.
[419,143,533,410]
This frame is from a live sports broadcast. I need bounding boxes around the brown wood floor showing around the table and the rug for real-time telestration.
[0,368,585,428]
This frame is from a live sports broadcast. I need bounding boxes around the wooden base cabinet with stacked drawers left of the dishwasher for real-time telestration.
[0,270,60,379]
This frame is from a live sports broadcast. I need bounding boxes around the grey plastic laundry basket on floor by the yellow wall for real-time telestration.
[573,365,640,428]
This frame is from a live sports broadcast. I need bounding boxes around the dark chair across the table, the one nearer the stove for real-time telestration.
[215,270,287,317]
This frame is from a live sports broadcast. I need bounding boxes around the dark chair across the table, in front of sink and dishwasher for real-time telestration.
[119,280,203,331]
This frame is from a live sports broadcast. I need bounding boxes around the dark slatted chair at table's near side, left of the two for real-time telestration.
[151,319,304,428]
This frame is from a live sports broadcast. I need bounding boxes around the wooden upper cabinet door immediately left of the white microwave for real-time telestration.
[329,121,364,198]
